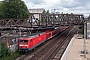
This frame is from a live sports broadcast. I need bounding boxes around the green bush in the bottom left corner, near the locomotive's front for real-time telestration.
[0,43,19,60]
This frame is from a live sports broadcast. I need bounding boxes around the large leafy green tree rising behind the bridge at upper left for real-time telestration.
[4,0,30,18]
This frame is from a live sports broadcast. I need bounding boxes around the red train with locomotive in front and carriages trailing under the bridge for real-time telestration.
[18,26,67,51]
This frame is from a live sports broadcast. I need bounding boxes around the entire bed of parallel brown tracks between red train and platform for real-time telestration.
[16,27,75,60]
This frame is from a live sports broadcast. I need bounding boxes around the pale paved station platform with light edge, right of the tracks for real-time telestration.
[61,35,90,60]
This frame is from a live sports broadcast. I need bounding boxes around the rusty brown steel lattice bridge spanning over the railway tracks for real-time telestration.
[0,13,84,30]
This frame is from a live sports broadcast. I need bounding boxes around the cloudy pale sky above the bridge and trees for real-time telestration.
[0,0,90,16]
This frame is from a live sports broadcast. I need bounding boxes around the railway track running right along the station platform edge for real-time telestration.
[42,26,75,60]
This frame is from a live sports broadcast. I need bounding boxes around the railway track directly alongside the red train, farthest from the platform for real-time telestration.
[15,26,66,60]
